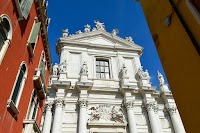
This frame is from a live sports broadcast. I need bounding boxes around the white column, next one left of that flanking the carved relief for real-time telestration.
[52,99,63,133]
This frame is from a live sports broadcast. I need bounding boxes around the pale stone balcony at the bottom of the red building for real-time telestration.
[23,119,42,133]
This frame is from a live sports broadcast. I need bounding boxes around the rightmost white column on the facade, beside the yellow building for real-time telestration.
[168,107,185,133]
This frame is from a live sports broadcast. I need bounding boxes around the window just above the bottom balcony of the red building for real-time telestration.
[27,90,39,120]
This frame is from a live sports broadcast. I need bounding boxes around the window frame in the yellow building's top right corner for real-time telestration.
[185,0,200,24]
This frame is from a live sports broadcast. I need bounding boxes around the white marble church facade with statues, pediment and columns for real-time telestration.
[42,21,185,133]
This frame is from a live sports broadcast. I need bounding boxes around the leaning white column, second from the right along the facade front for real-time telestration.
[145,102,160,133]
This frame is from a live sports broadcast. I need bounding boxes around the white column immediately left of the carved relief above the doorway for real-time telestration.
[78,99,88,133]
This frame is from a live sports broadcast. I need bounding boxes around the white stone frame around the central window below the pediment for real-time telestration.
[94,57,113,80]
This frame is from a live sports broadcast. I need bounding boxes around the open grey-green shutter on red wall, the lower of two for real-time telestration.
[29,22,41,49]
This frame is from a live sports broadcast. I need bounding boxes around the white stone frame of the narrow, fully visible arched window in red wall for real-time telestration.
[9,61,28,108]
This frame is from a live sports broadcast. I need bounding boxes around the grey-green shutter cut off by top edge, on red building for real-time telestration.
[21,0,33,19]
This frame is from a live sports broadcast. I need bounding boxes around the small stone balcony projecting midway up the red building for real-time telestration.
[33,68,46,100]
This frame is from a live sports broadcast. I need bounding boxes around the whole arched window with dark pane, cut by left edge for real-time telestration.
[0,14,12,63]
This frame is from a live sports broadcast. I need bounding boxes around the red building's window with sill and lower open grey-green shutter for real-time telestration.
[27,20,41,57]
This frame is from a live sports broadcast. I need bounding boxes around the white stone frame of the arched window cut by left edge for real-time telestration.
[0,14,13,64]
